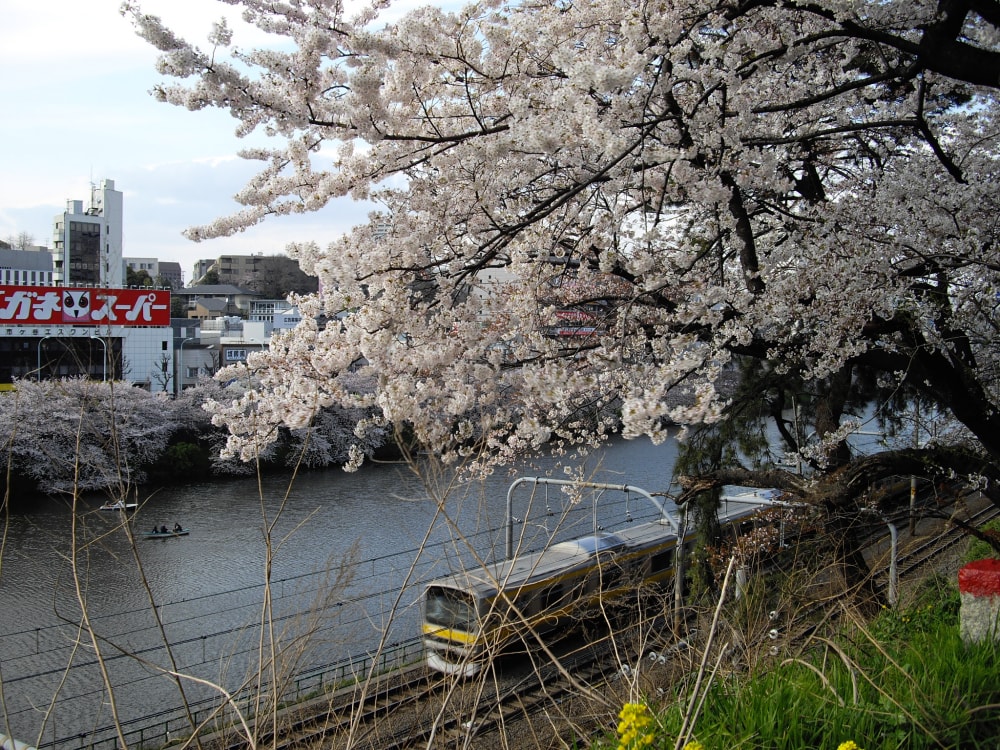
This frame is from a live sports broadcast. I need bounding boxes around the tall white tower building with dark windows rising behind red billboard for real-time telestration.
[52,180,124,287]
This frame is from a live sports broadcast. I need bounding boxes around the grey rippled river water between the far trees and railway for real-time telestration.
[0,439,676,747]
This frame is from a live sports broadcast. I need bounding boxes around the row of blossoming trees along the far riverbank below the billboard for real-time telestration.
[0,378,387,506]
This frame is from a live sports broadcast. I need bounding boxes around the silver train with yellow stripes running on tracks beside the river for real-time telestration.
[422,490,772,677]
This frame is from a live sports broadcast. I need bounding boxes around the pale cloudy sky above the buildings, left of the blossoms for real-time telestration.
[0,0,426,283]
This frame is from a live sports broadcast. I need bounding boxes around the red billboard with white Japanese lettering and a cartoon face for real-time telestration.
[0,285,170,326]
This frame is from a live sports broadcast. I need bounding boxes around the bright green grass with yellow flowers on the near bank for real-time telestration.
[595,578,1000,750]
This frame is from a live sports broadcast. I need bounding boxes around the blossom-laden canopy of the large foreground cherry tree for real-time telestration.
[124,0,1000,512]
